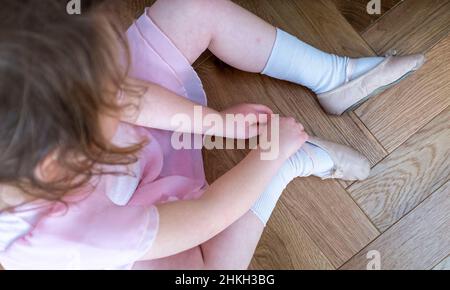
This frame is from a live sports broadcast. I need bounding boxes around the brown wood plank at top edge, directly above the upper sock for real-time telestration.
[238,0,374,57]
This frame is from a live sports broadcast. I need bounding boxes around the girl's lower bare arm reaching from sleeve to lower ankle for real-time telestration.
[141,118,307,260]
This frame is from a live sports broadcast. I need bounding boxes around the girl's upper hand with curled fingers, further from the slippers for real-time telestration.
[220,104,273,139]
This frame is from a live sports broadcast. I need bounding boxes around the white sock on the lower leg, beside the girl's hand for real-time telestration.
[251,143,334,225]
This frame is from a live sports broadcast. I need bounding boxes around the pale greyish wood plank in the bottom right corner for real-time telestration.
[342,182,450,270]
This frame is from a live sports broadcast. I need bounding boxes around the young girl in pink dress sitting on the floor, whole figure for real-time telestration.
[0,0,424,269]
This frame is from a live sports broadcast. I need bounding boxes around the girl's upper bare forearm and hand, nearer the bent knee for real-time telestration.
[121,80,272,138]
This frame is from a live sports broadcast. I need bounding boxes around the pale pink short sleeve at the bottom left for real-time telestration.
[0,202,159,269]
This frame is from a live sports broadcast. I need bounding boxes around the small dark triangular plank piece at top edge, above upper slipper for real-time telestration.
[333,0,400,33]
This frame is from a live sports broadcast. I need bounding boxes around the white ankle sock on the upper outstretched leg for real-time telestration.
[262,29,383,94]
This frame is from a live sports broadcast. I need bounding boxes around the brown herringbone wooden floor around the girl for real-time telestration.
[119,0,450,269]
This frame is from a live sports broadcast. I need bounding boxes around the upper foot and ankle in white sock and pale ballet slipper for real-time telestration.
[262,29,425,115]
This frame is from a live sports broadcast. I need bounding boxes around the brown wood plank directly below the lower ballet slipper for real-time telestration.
[282,177,379,267]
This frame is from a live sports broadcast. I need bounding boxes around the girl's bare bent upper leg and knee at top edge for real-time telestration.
[148,0,276,73]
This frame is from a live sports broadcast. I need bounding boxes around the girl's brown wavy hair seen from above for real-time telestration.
[0,0,144,200]
